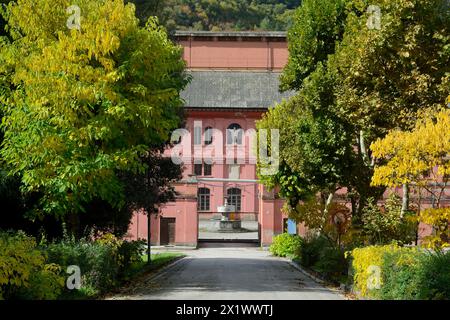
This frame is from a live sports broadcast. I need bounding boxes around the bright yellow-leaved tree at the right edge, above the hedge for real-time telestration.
[371,109,450,246]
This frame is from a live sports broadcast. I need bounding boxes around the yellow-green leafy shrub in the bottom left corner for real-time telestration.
[0,232,64,299]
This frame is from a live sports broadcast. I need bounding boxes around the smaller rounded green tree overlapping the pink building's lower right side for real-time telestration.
[257,66,352,201]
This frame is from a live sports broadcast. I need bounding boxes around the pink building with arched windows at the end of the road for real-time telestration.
[129,31,291,246]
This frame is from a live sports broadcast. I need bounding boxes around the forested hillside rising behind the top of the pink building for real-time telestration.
[130,0,301,31]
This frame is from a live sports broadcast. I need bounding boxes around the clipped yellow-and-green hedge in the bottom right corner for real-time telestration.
[351,245,450,300]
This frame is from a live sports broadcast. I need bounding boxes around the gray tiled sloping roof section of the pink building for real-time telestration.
[181,71,293,109]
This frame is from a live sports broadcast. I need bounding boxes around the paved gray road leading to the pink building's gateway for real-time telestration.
[108,247,344,300]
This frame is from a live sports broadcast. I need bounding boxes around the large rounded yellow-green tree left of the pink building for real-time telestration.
[0,0,188,218]
